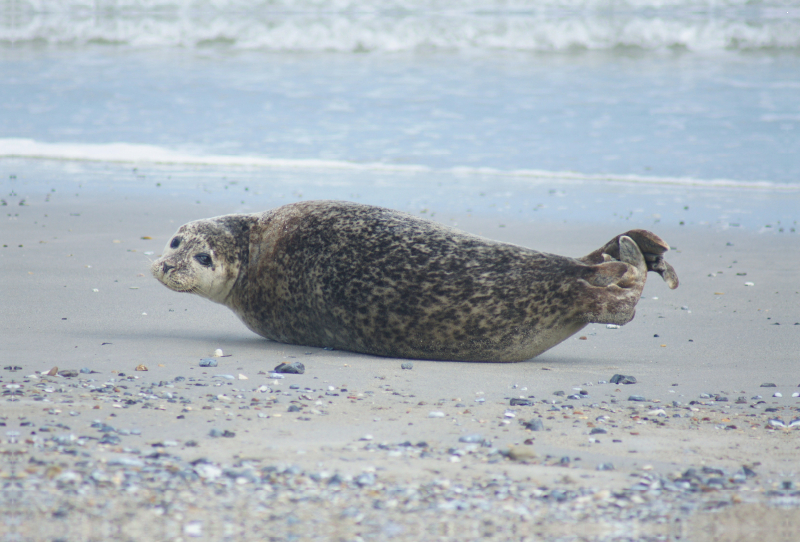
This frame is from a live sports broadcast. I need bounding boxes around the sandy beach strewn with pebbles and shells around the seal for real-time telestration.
[0,167,800,541]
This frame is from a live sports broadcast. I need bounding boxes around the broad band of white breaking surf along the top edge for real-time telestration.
[0,0,800,52]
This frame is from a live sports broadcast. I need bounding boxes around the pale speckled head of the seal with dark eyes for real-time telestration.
[150,215,249,304]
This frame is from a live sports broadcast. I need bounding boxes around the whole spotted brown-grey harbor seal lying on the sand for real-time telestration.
[152,201,678,362]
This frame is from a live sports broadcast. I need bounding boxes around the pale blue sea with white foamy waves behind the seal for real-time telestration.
[0,0,800,234]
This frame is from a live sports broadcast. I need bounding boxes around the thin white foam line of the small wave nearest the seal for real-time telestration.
[0,139,800,191]
